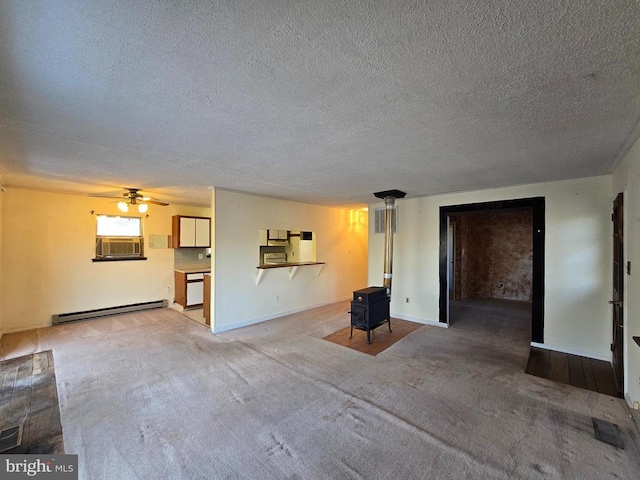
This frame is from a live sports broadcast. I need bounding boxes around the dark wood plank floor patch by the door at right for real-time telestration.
[526,348,622,398]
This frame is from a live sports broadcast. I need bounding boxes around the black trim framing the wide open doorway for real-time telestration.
[440,197,545,343]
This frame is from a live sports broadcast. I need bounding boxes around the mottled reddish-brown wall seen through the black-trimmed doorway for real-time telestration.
[452,211,533,302]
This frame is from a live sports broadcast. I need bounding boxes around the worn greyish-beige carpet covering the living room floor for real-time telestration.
[0,302,640,479]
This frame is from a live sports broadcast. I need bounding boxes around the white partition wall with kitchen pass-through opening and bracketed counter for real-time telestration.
[212,189,367,332]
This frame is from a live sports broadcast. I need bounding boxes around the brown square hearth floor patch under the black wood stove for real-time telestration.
[324,318,424,355]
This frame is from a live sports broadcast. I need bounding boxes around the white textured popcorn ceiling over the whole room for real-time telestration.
[0,0,640,206]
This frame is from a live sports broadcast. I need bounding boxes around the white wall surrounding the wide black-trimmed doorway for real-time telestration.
[369,176,611,360]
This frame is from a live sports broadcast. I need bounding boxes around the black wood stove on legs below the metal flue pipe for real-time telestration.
[349,287,391,343]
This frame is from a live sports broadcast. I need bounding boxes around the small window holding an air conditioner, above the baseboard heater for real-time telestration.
[94,215,145,261]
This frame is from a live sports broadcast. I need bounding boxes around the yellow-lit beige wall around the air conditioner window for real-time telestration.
[0,188,210,333]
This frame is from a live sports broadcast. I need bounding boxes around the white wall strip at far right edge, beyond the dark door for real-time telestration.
[610,140,640,406]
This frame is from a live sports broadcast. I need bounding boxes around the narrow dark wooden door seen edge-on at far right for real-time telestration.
[609,193,624,392]
